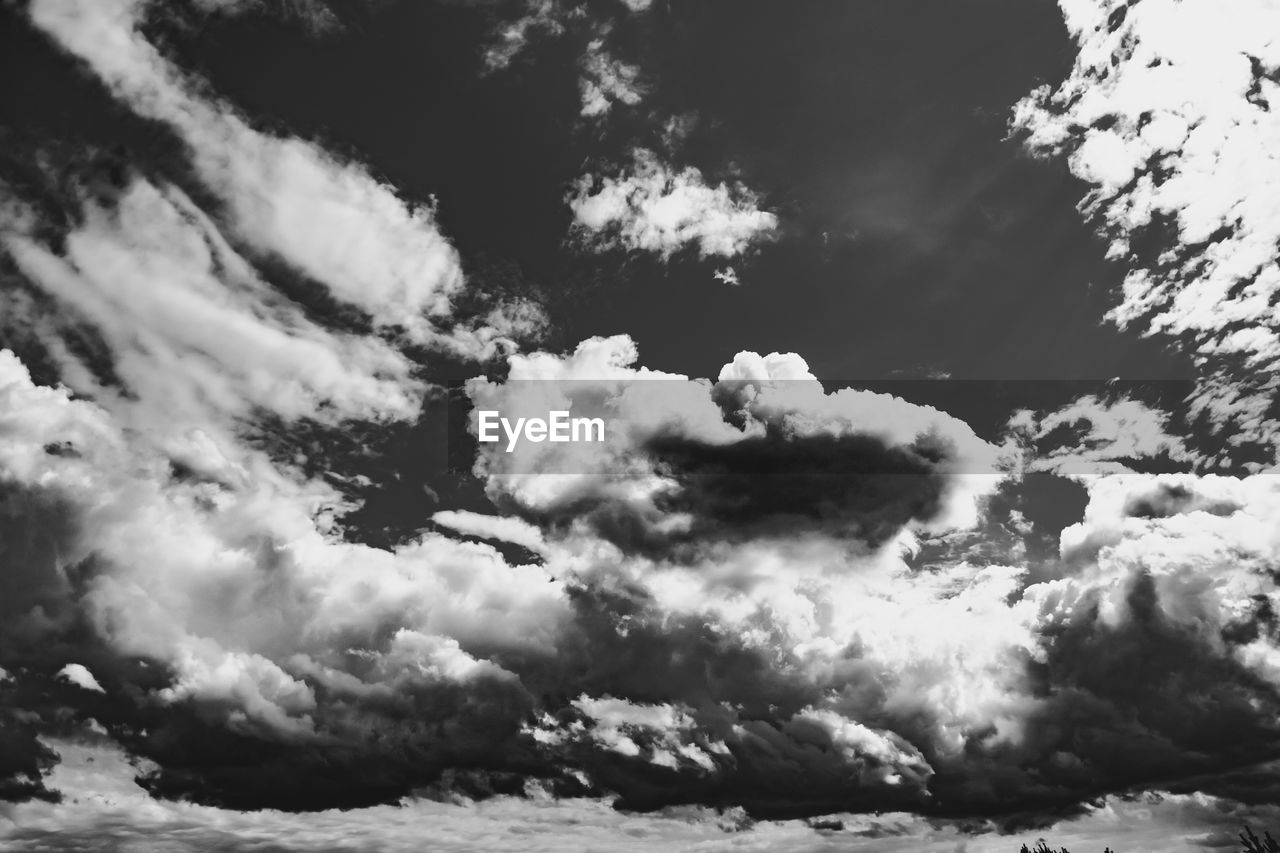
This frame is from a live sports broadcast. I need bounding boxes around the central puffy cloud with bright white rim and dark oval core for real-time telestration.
[468,337,998,556]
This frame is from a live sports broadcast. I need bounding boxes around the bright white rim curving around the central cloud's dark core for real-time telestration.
[468,336,1001,534]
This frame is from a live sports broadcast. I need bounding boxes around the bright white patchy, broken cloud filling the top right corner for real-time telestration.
[1014,0,1280,455]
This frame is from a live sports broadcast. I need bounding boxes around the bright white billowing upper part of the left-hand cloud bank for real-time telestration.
[0,352,564,731]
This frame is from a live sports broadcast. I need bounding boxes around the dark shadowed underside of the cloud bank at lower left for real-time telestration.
[0,481,539,811]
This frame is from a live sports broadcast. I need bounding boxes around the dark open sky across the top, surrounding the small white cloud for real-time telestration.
[0,0,1188,379]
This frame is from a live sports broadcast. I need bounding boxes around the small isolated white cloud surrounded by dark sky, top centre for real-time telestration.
[570,149,778,260]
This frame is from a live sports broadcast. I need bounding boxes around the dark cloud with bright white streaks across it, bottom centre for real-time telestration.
[509,588,932,818]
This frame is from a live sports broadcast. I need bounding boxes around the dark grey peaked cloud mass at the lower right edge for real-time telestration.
[931,575,1280,829]
